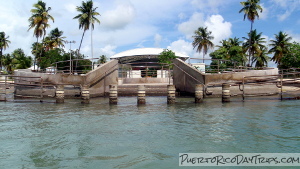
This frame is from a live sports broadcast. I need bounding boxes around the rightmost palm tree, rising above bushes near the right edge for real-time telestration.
[269,31,292,66]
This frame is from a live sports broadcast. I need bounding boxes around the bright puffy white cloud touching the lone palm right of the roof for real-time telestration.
[205,15,232,45]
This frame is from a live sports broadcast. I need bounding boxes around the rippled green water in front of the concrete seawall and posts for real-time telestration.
[0,97,300,169]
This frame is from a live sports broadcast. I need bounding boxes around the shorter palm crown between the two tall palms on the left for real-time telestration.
[44,28,66,51]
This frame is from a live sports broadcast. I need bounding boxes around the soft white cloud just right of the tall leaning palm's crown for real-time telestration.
[101,3,135,30]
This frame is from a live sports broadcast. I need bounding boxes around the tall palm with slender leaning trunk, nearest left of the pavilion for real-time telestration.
[73,0,100,53]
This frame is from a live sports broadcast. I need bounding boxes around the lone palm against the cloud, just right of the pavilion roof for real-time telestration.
[192,27,214,63]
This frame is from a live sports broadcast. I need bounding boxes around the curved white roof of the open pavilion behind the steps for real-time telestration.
[110,48,189,59]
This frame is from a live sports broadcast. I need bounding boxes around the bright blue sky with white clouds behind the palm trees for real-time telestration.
[0,0,300,66]
